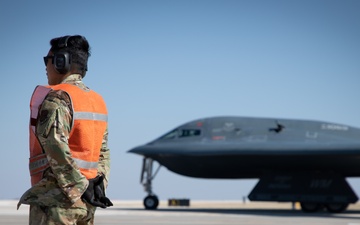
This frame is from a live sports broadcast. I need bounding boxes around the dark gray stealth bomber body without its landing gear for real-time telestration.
[130,117,360,178]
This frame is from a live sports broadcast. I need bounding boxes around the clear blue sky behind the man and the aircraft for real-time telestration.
[0,0,360,200]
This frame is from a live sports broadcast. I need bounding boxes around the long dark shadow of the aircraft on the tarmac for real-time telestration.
[113,208,360,220]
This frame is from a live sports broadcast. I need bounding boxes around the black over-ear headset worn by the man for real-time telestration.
[54,36,71,74]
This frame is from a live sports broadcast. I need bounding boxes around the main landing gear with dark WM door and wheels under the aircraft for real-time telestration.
[249,172,358,213]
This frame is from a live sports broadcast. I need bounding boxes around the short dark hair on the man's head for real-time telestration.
[50,35,91,77]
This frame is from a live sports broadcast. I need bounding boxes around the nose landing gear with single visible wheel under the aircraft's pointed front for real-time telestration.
[140,157,161,209]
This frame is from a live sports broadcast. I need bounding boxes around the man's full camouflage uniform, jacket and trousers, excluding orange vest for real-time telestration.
[18,74,110,225]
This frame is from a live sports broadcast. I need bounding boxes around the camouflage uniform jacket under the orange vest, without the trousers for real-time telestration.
[18,74,110,223]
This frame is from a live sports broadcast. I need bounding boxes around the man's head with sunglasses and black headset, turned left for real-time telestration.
[44,35,90,85]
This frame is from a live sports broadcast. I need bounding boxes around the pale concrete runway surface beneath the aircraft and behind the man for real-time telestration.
[0,200,360,225]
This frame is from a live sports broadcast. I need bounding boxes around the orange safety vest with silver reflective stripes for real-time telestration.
[29,84,107,185]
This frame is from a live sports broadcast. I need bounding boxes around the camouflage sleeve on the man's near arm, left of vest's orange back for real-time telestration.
[36,91,89,202]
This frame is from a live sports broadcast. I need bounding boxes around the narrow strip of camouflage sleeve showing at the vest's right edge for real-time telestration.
[98,128,110,187]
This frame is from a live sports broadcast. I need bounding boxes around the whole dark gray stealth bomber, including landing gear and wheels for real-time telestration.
[129,117,360,212]
